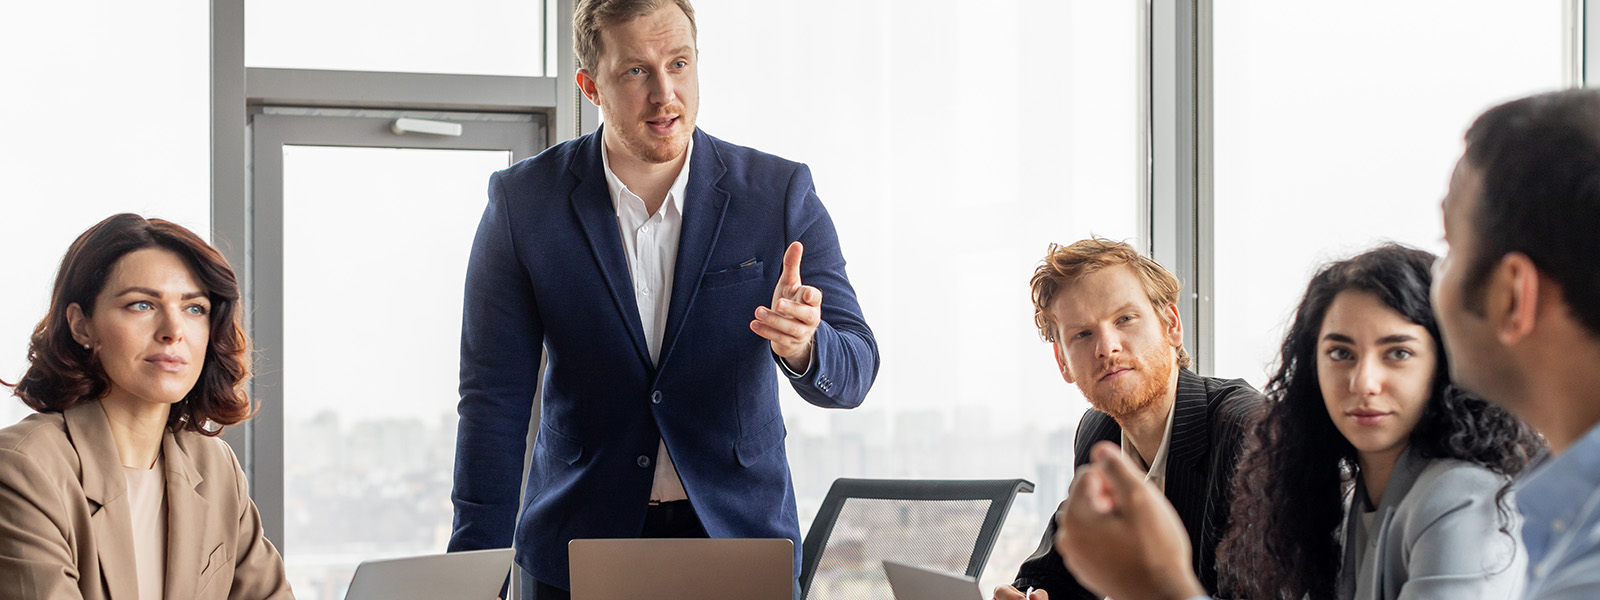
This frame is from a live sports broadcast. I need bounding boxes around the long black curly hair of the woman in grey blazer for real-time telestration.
[1218,243,1544,600]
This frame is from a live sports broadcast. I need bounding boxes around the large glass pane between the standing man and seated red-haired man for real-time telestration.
[694,0,1144,589]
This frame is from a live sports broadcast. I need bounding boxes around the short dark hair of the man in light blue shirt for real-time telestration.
[1466,90,1600,334]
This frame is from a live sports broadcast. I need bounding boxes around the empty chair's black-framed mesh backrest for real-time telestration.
[800,478,1034,600]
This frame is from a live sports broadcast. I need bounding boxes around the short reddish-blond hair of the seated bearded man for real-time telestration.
[1029,237,1194,368]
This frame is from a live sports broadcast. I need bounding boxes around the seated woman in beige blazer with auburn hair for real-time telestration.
[0,214,293,600]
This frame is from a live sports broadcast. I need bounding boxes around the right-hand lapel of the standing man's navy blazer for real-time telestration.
[658,130,732,373]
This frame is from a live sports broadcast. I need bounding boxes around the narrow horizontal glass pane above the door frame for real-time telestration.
[245,0,546,77]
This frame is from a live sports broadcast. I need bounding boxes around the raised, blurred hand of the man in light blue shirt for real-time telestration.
[1056,442,1206,600]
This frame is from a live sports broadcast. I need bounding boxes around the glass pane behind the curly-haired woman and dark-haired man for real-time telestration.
[1214,0,1563,386]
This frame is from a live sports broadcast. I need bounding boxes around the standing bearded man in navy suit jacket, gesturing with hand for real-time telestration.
[450,0,878,600]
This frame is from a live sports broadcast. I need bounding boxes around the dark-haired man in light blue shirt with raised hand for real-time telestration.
[1056,90,1600,600]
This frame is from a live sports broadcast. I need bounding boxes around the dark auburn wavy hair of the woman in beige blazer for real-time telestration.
[11,213,251,435]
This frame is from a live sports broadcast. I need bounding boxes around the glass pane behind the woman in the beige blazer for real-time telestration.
[0,2,211,426]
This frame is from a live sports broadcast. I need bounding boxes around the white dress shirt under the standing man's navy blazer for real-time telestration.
[600,139,694,502]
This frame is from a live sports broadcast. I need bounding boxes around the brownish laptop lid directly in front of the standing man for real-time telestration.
[566,538,795,600]
